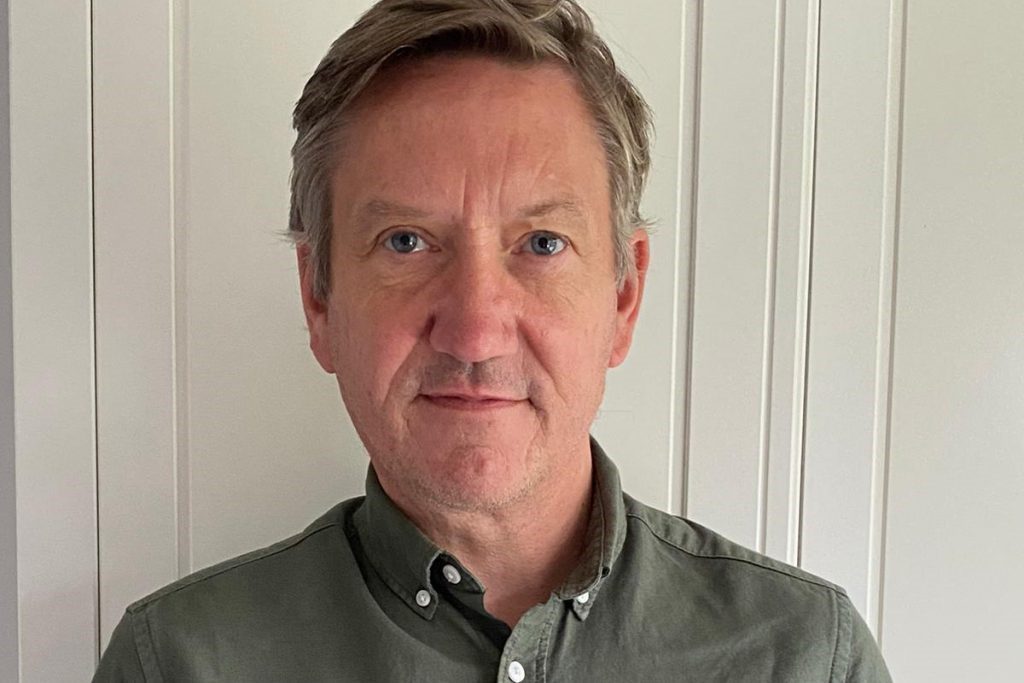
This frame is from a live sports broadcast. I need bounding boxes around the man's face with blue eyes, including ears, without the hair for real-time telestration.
[299,56,647,509]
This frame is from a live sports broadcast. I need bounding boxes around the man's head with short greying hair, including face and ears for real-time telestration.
[292,0,649,509]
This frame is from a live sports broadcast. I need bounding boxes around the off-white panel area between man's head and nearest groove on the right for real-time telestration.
[585,0,695,513]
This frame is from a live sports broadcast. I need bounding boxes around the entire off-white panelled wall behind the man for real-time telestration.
[6,0,1024,681]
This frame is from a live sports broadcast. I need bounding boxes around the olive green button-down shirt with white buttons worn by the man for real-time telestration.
[99,442,891,683]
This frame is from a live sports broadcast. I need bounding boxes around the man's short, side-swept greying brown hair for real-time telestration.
[288,0,652,301]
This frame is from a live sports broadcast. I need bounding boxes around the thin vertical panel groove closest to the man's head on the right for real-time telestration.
[679,0,703,516]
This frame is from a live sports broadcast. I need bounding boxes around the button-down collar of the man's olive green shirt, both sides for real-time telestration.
[355,437,626,620]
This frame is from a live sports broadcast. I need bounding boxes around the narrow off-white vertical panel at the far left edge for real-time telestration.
[9,0,98,683]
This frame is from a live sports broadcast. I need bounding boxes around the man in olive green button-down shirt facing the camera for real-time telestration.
[96,0,888,683]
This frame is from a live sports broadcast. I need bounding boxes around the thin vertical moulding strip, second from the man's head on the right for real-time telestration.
[756,0,785,553]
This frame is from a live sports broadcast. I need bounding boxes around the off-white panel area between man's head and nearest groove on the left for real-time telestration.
[179,0,371,568]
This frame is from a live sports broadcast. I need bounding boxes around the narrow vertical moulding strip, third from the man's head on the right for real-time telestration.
[786,0,821,566]
